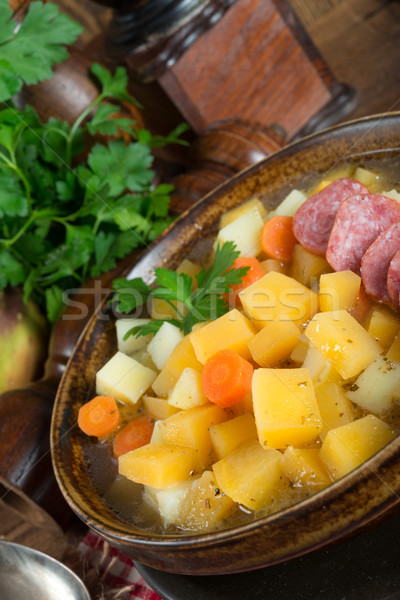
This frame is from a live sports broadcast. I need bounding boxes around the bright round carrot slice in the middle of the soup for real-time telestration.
[201,349,253,408]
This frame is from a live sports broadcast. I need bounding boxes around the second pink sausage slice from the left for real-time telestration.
[326,193,400,274]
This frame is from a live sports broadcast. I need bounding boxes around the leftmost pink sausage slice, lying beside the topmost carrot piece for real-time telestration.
[293,177,368,256]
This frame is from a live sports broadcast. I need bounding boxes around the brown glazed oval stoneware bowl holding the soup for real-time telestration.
[51,113,400,575]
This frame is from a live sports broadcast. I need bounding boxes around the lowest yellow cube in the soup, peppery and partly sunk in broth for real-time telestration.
[176,471,236,532]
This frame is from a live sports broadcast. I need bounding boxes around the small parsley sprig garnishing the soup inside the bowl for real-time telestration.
[112,242,249,337]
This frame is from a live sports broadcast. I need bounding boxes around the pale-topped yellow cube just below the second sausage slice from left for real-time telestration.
[319,271,361,312]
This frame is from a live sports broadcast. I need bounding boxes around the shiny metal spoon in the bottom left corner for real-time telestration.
[0,540,90,600]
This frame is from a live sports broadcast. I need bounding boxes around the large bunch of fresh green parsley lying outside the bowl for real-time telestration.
[0,0,186,322]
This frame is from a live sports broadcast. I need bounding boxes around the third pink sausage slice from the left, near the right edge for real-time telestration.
[361,222,400,303]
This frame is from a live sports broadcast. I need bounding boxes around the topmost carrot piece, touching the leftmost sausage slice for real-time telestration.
[261,215,296,262]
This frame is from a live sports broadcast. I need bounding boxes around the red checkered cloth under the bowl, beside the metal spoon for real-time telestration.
[78,532,161,600]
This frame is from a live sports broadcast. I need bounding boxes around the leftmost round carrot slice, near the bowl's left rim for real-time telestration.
[78,396,120,437]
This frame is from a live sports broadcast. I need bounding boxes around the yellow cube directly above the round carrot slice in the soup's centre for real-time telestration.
[190,308,256,365]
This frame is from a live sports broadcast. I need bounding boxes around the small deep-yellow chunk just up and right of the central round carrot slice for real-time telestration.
[248,318,300,367]
